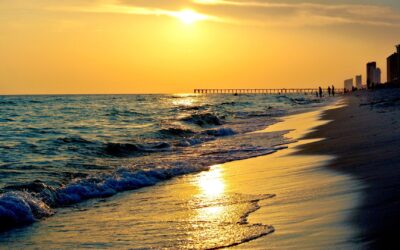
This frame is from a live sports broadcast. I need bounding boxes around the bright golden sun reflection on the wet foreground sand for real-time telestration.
[186,165,273,249]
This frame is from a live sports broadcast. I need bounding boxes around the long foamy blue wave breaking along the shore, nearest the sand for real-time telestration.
[0,141,288,230]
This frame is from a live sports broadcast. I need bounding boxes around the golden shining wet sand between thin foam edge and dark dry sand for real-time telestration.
[225,103,364,249]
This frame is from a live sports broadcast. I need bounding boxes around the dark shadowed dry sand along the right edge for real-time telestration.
[299,89,400,249]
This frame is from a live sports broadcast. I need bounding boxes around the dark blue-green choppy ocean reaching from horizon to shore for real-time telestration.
[0,94,324,246]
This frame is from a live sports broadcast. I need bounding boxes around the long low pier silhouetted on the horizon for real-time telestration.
[194,88,343,95]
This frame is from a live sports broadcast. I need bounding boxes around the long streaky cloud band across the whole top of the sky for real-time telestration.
[0,0,400,27]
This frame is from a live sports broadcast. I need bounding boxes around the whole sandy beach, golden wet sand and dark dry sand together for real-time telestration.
[1,90,400,249]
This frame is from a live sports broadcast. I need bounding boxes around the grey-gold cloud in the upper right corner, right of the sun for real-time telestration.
[193,0,400,27]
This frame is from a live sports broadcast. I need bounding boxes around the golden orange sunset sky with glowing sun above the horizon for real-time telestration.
[0,0,400,94]
